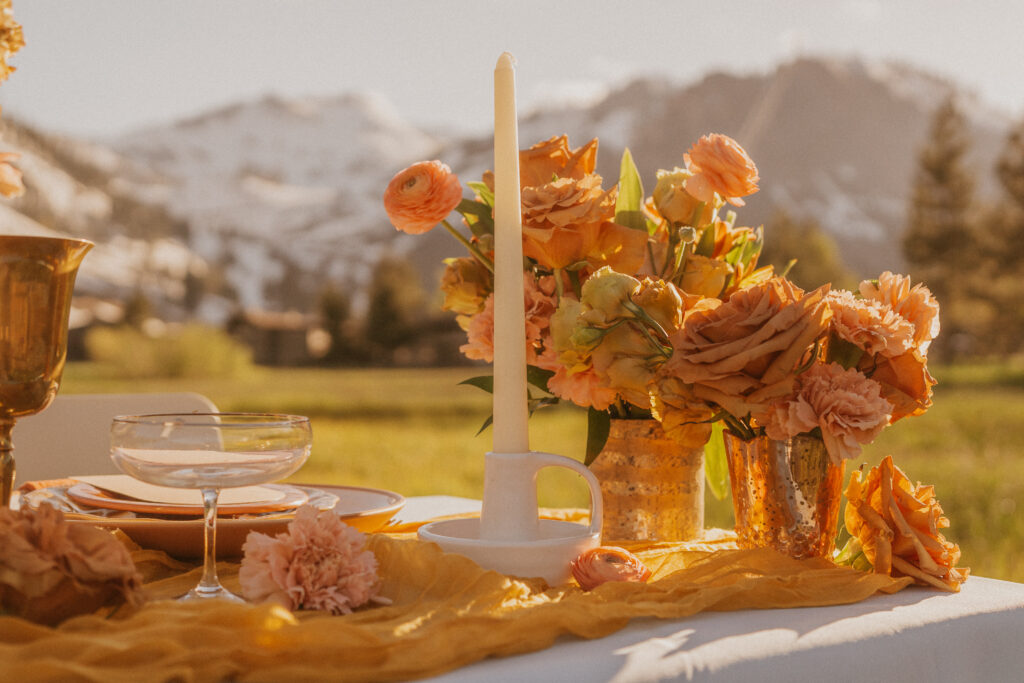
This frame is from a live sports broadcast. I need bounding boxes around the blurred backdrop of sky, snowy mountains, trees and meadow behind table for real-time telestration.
[0,0,1024,580]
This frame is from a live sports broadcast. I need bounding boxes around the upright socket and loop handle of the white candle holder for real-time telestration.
[480,451,604,541]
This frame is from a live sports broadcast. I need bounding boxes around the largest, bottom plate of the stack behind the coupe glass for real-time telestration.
[58,484,406,559]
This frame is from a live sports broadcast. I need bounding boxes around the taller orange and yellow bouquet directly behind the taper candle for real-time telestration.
[384,135,771,481]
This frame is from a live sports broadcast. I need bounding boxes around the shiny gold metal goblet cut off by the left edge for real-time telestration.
[0,236,92,507]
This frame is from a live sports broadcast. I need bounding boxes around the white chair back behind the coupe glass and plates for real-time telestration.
[11,392,217,486]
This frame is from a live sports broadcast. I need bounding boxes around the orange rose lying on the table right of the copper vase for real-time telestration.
[836,456,970,593]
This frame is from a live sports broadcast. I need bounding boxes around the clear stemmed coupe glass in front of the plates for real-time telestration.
[111,413,312,601]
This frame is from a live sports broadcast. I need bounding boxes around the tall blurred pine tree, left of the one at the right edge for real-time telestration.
[903,96,981,358]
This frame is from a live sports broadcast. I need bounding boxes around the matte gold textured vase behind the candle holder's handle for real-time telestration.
[590,420,705,543]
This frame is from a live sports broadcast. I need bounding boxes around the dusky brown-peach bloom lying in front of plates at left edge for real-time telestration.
[0,505,142,625]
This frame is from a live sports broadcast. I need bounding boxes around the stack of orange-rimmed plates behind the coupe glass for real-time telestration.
[22,475,406,559]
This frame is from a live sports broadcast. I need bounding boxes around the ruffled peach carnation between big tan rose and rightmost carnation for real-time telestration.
[825,290,914,358]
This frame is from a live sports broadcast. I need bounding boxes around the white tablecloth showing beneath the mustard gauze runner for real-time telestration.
[401,497,1024,683]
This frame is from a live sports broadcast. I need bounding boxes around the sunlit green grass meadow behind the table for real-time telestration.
[61,364,1024,582]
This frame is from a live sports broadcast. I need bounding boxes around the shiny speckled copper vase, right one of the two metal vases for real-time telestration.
[725,431,845,558]
